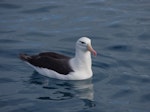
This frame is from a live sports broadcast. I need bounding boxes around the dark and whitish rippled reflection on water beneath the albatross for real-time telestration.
[30,72,95,108]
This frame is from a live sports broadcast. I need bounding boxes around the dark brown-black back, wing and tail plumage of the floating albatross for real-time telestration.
[20,52,73,75]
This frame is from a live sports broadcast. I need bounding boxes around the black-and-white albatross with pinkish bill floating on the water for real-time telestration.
[20,37,97,80]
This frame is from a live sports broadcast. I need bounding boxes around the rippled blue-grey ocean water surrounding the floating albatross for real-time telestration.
[0,0,150,112]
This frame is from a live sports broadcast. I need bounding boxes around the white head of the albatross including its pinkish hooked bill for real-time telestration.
[76,37,97,56]
